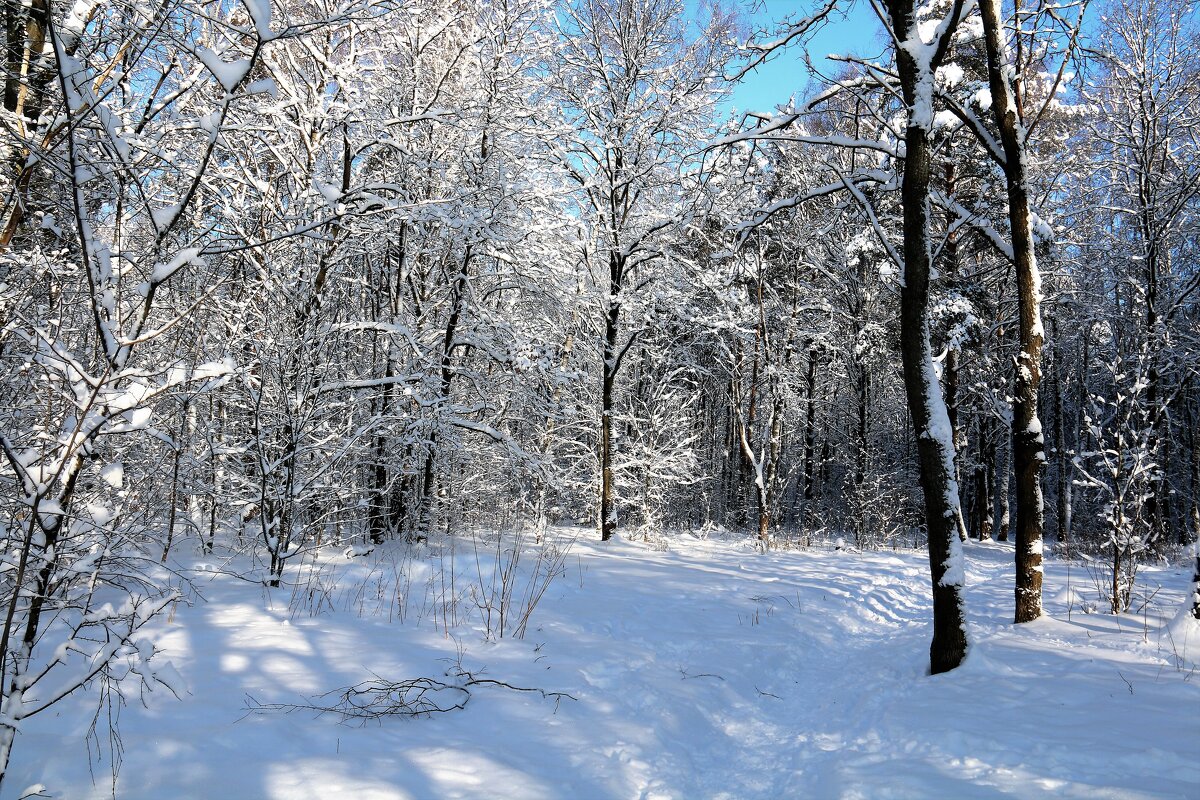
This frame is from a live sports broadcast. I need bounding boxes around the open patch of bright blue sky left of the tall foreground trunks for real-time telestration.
[700,0,883,112]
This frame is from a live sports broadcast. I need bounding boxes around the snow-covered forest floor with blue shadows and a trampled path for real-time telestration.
[5,536,1200,800]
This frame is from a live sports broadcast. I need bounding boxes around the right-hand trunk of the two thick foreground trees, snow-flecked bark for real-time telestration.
[979,0,1045,622]
